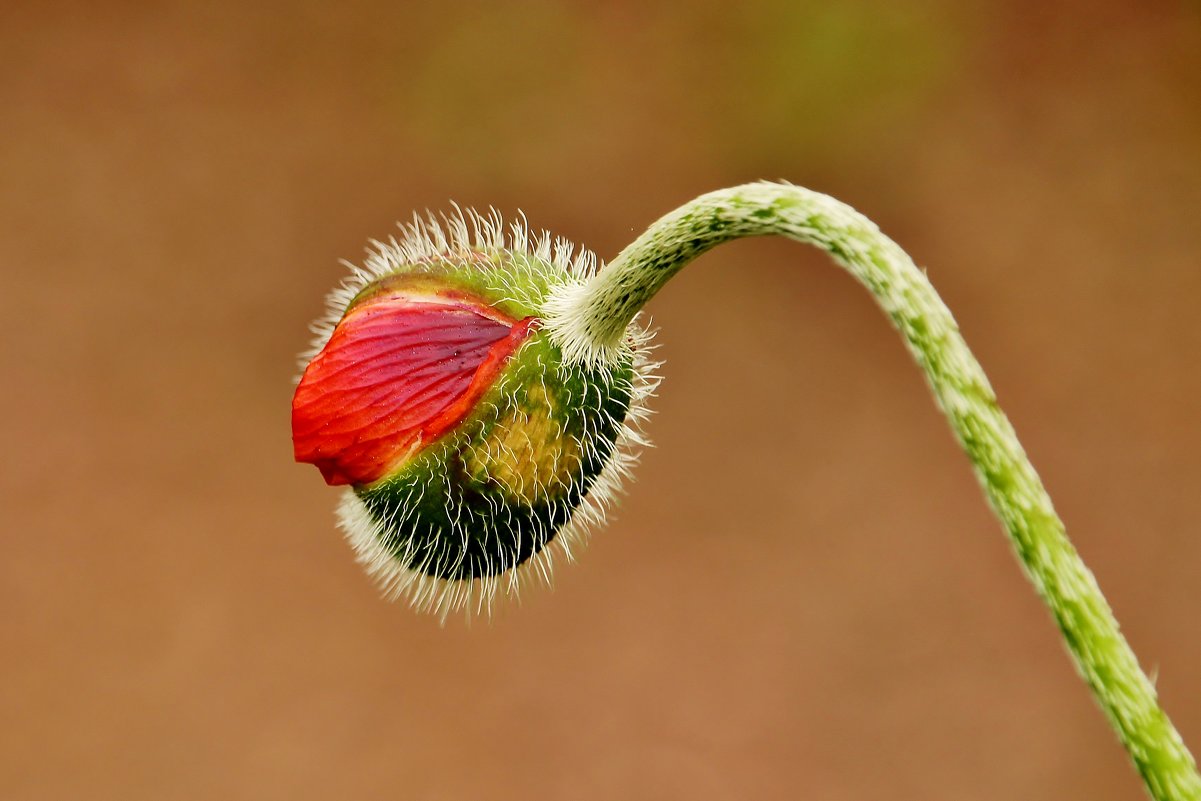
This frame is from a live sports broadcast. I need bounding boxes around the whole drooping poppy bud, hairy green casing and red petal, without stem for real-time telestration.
[292,214,656,616]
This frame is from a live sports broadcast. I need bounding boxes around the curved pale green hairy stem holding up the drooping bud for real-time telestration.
[545,183,1201,801]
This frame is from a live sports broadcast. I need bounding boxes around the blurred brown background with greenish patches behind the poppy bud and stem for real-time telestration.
[0,0,1201,801]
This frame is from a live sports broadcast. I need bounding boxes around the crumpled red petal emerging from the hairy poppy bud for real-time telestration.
[292,291,537,484]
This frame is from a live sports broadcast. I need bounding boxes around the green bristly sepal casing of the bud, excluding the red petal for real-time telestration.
[296,206,658,618]
